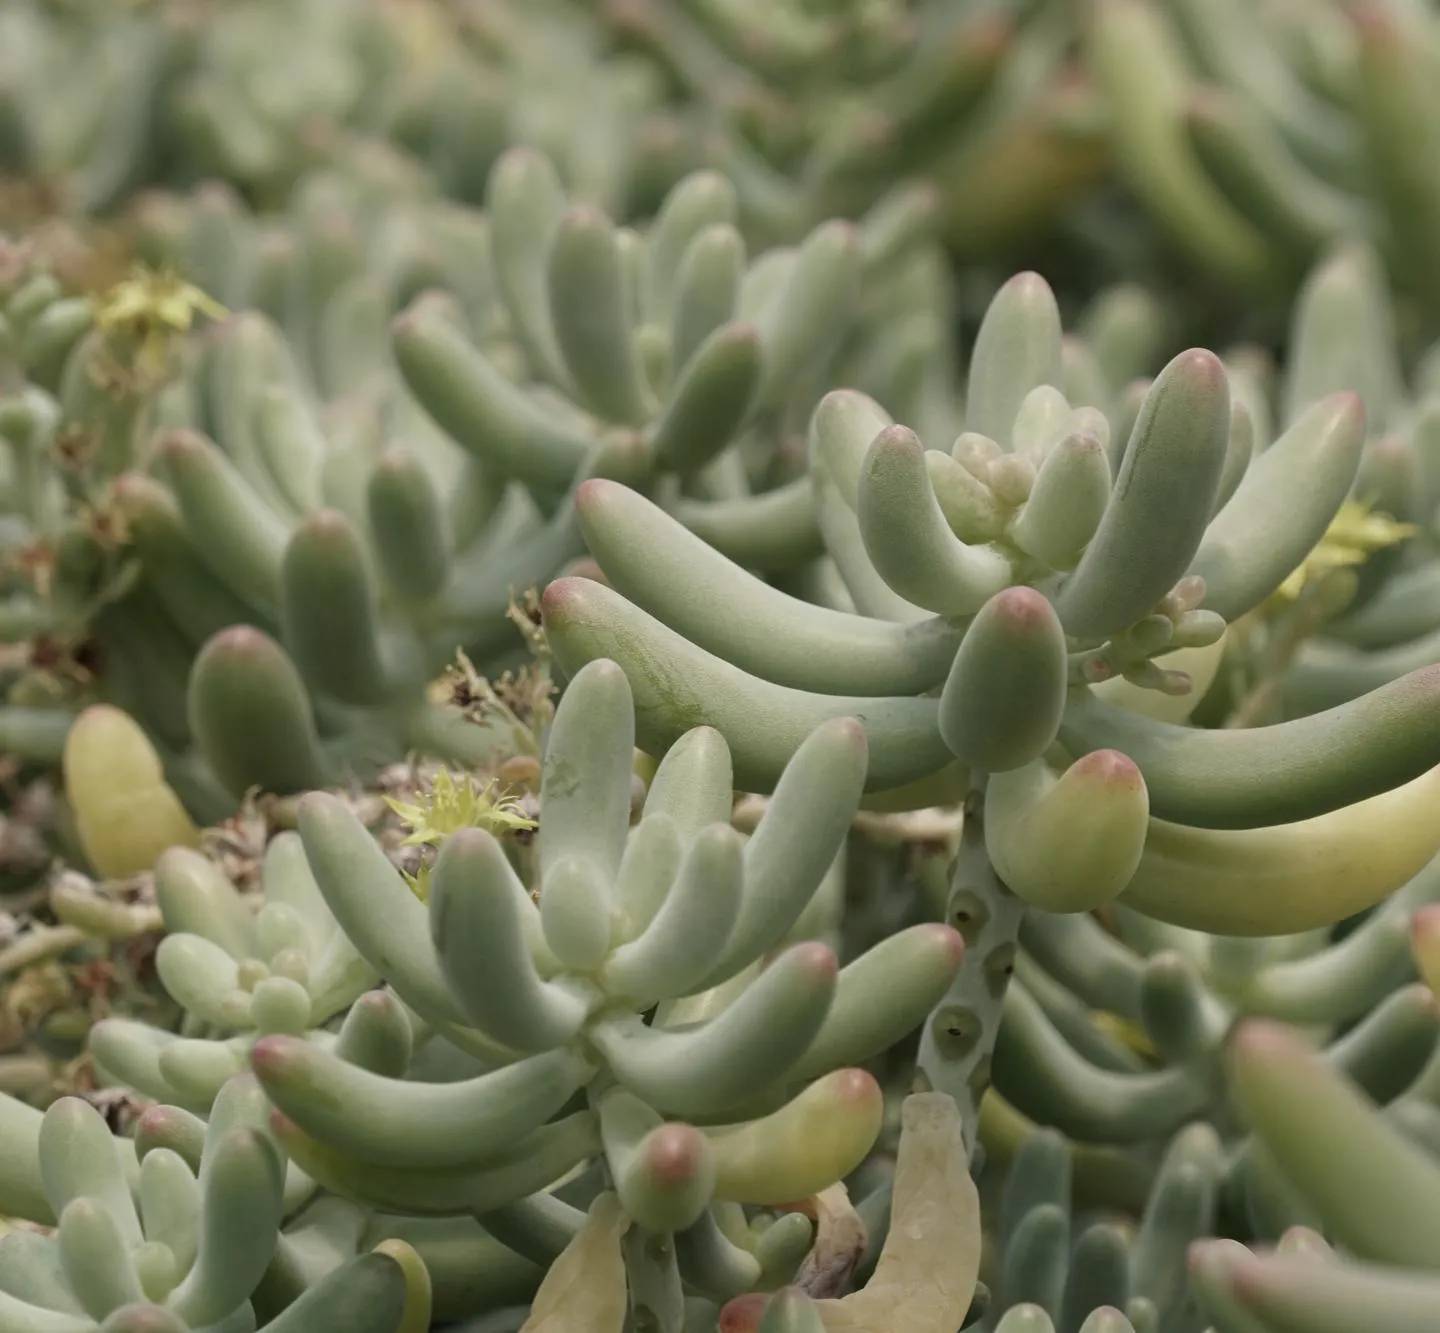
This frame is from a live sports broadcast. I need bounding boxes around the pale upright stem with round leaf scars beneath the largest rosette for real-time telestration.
[920,786,1025,1156]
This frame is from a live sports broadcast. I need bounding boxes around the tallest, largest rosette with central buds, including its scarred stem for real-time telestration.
[543,256,1440,1163]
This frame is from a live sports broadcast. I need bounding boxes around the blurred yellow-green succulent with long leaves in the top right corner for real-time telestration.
[1083,0,1440,325]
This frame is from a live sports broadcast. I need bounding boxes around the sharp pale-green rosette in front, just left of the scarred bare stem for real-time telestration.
[236,662,959,1323]
